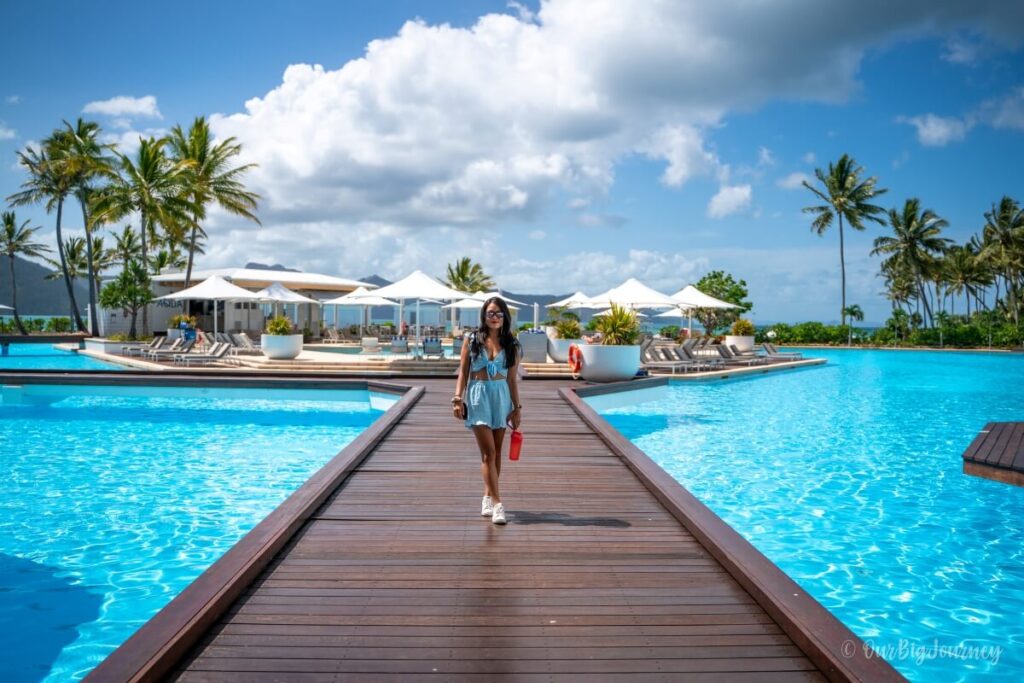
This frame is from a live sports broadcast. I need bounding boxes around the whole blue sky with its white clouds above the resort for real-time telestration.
[0,0,1024,322]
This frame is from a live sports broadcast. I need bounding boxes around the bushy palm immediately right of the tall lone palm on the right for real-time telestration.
[871,198,950,327]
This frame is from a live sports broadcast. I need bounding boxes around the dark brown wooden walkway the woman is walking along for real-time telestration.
[88,380,902,683]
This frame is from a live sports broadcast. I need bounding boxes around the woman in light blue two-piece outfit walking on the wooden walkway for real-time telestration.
[452,297,522,524]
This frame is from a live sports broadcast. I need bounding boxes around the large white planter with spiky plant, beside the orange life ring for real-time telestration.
[579,304,640,382]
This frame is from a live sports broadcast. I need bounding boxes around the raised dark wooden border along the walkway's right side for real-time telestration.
[558,385,906,682]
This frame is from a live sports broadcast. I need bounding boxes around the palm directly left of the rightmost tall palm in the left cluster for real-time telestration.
[93,137,194,336]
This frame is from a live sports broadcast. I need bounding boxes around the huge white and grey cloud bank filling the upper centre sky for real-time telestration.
[197,0,1024,278]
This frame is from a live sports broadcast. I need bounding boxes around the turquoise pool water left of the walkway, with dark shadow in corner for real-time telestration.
[0,385,393,683]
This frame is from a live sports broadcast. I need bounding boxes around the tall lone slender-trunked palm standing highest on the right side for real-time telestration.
[804,155,887,325]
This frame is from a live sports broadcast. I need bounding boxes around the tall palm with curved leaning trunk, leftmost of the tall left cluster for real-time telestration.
[7,142,85,332]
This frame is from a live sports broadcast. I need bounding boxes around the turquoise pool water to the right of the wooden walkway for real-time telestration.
[587,349,1024,681]
